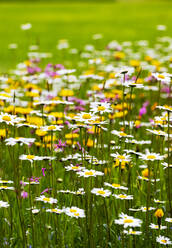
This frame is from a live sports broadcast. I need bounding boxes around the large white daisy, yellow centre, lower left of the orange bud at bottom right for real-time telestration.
[115,213,142,228]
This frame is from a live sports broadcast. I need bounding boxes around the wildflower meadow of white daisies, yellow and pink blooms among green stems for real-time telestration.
[0,0,172,248]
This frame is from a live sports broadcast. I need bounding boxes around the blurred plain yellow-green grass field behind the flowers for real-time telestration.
[0,1,172,72]
